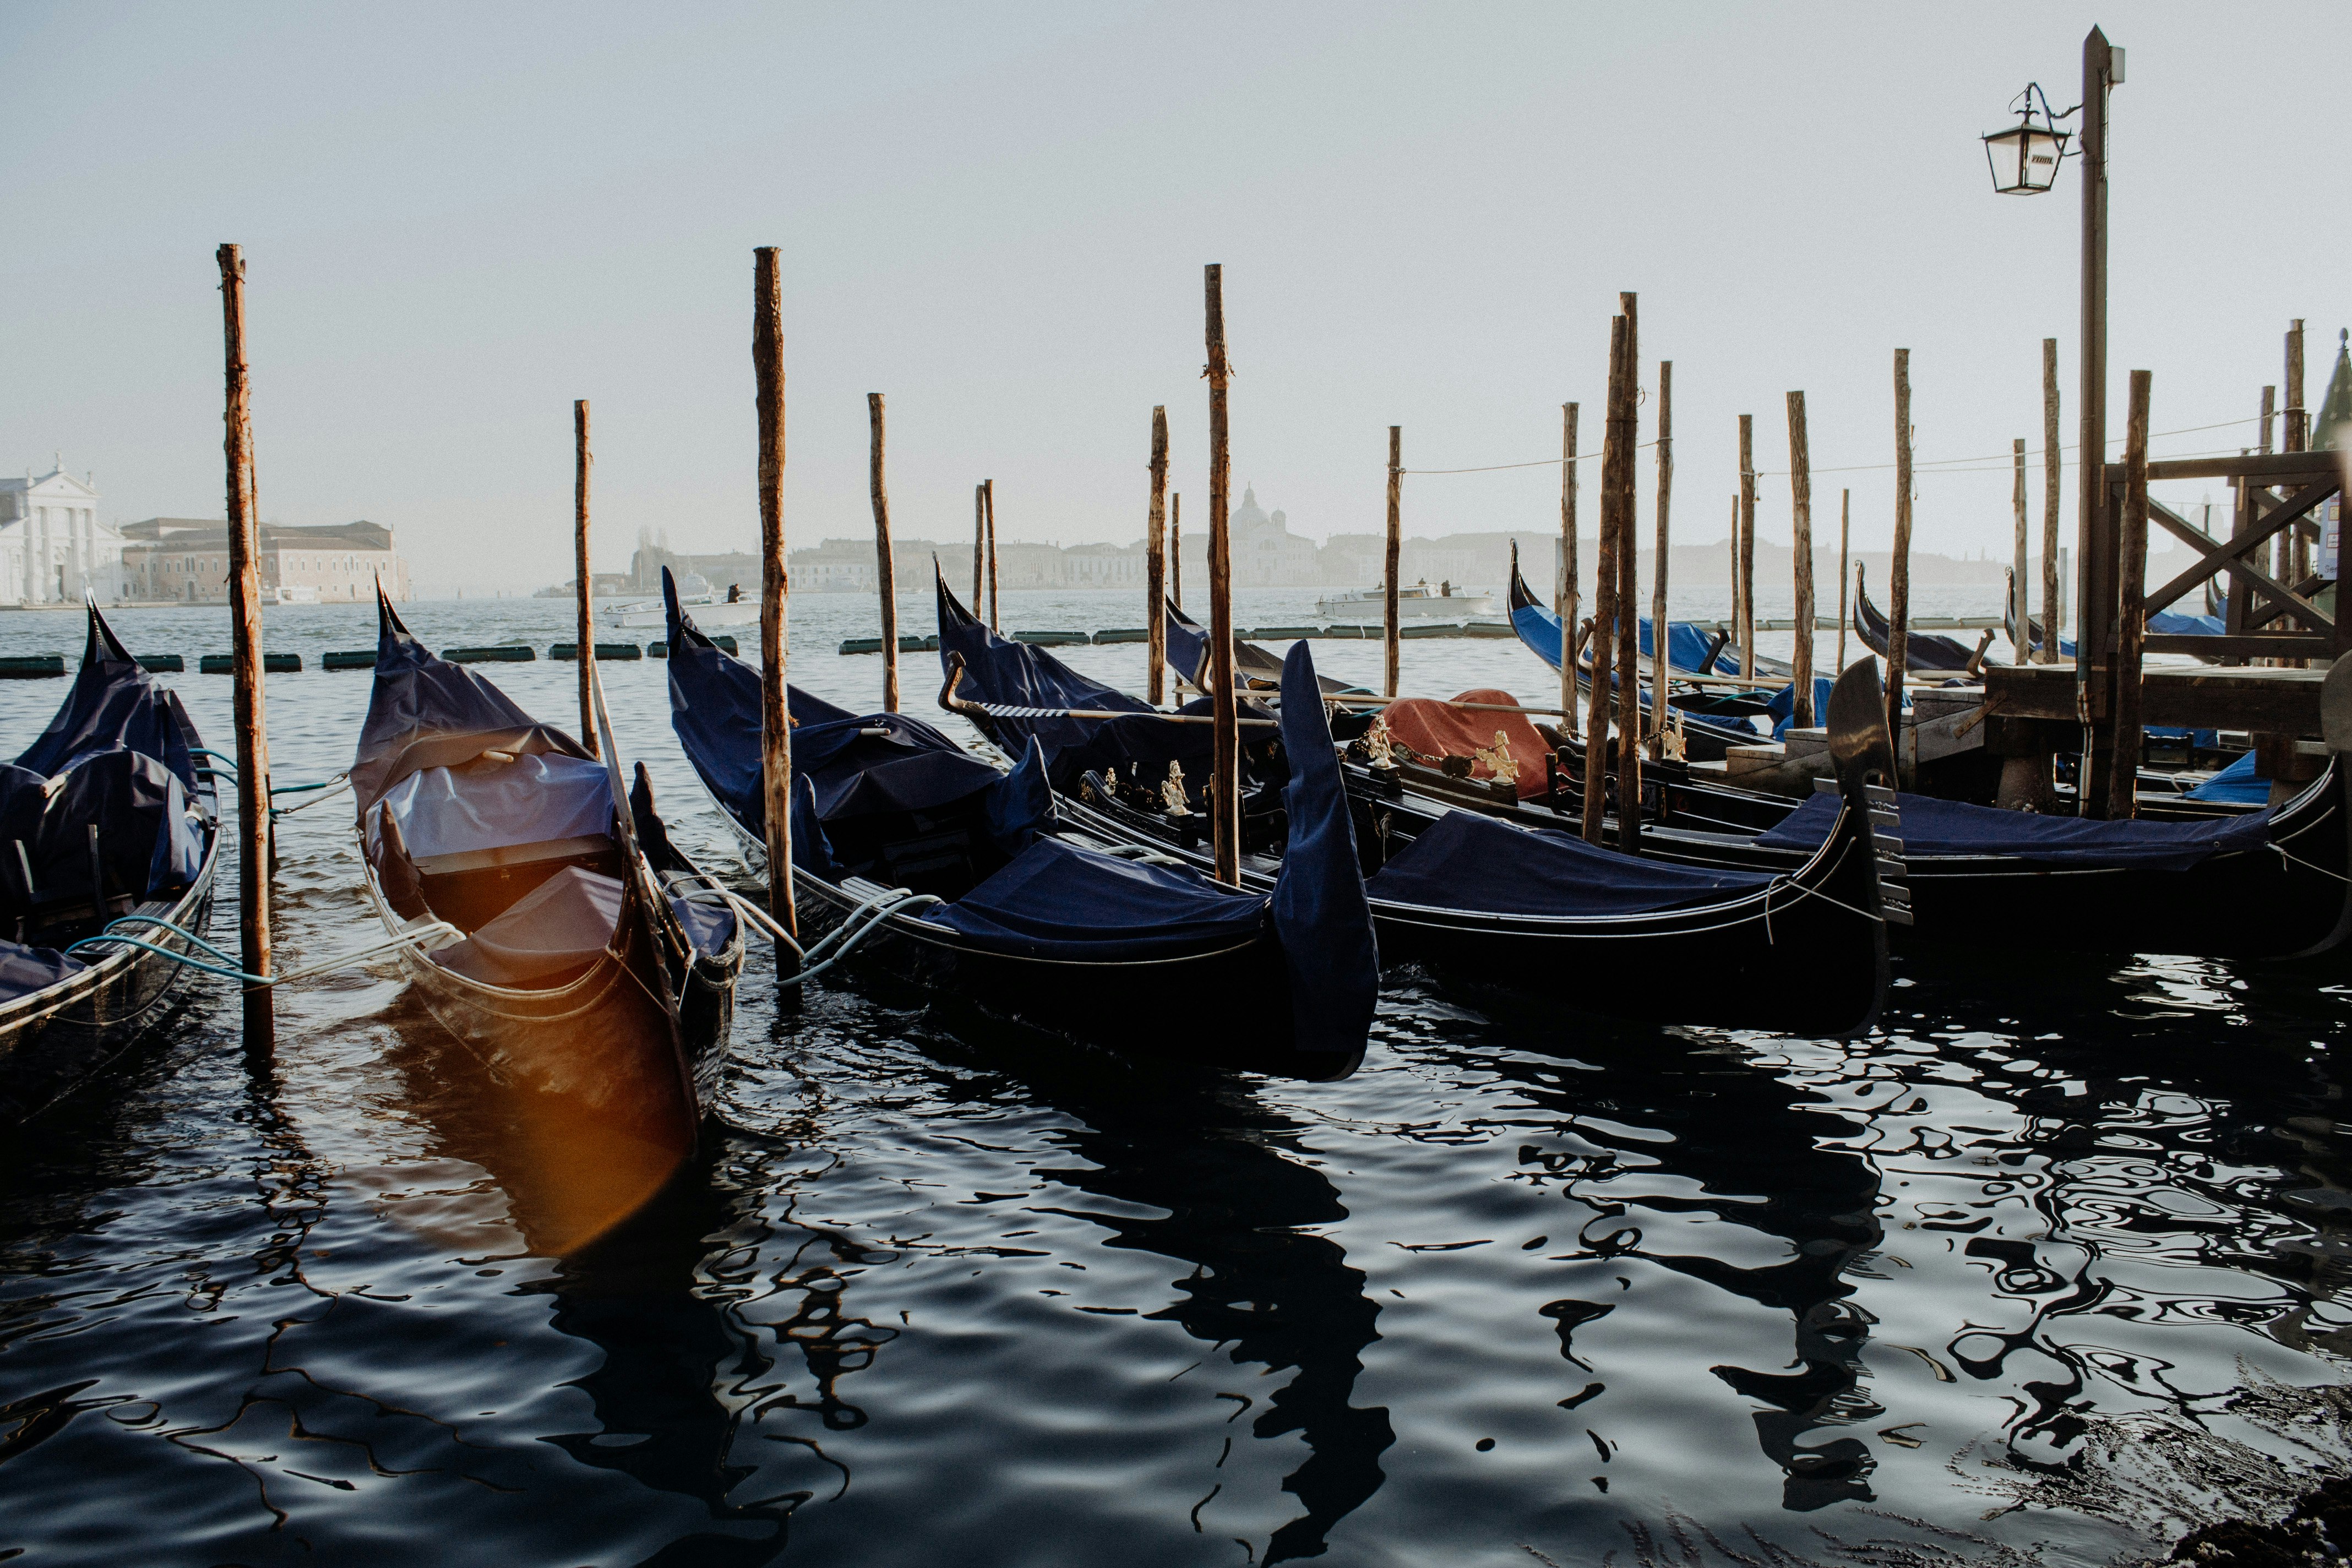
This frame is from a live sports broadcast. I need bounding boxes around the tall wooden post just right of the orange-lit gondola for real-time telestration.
[753,244,799,945]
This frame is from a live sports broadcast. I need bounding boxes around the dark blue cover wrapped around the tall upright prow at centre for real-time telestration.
[1275,642,1381,1053]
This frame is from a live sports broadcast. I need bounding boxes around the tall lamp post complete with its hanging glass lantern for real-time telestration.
[1983,28,2116,816]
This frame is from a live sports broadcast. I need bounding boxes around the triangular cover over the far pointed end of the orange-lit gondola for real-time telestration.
[351,590,588,823]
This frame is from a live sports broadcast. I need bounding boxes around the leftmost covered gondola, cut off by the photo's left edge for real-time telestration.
[0,604,221,1126]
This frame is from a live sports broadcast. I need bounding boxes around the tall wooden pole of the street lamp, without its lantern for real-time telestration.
[2079,28,2117,816]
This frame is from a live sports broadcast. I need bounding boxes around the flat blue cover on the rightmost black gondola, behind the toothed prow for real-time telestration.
[1757,794,2269,872]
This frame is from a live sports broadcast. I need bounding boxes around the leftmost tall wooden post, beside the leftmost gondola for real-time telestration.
[214,244,277,1051]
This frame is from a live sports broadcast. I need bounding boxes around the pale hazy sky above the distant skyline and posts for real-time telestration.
[0,0,2352,592]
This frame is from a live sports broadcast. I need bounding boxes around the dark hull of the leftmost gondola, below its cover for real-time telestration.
[0,827,224,1126]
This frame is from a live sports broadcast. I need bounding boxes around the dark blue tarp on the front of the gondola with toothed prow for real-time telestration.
[1364,811,1773,917]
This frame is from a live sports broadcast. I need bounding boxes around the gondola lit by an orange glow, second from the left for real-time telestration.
[351,592,743,1161]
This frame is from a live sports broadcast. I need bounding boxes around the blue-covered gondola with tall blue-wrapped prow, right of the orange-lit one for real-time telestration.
[663,576,1378,1079]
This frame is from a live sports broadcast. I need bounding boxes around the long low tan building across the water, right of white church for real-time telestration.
[122,517,409,604]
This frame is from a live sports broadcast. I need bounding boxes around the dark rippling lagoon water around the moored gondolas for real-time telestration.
[0,592,2352,1568]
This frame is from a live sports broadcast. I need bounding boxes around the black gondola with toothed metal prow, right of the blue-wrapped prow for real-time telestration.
[939,571,1903,1035]
